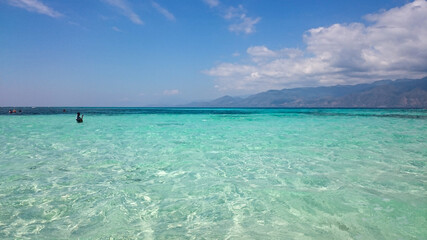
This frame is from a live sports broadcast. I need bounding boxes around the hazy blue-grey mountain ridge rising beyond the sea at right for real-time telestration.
[186,77,427,108]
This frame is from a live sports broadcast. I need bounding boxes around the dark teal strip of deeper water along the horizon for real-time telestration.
[0,107,427,118]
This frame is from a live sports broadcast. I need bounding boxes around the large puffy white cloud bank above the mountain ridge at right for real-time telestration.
[204,0,427,91]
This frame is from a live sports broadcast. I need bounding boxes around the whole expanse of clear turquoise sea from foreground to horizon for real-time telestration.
[0,108,427,239]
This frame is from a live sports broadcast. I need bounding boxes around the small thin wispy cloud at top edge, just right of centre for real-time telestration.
[204,0,261,34]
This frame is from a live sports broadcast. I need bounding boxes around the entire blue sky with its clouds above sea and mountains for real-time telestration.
[0,0,427,106]
